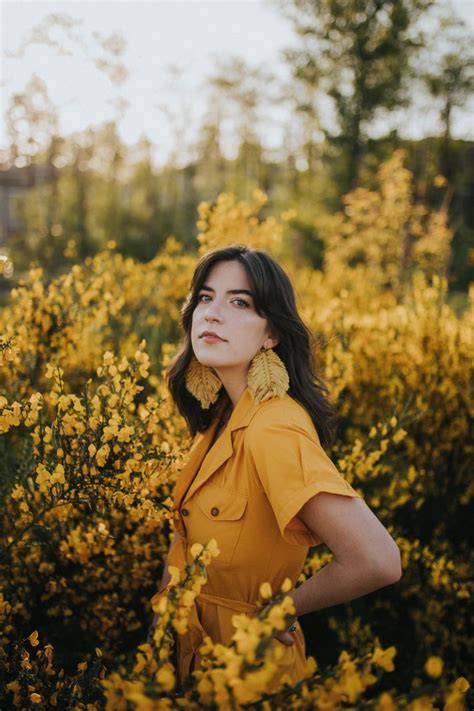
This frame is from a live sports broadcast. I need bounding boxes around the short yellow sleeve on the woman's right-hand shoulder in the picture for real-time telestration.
[246,413,362,546]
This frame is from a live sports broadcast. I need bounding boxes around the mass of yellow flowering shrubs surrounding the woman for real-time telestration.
[0,154,474,711]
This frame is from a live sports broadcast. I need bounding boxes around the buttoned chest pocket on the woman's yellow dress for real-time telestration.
[197,484,248,565]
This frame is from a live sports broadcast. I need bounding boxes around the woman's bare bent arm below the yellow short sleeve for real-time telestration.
[289,491,402,616]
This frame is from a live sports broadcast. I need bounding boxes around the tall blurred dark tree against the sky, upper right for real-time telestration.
[277,0,433,194]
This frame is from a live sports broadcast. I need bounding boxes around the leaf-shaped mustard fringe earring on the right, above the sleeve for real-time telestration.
[247,348,290,402]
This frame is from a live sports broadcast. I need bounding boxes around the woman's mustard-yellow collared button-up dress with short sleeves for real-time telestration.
[152,387,362,690]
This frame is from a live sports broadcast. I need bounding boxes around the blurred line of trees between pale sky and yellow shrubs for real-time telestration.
[1,0,474,290]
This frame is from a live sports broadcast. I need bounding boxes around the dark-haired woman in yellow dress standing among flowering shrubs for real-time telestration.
[148,245,401,687]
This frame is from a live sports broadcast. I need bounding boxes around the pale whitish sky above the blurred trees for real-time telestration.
[0,0,474,168]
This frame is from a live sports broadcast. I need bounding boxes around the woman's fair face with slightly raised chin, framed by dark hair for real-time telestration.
[191,261,278,378]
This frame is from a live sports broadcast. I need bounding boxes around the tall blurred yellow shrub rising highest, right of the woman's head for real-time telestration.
[325,150,452,295]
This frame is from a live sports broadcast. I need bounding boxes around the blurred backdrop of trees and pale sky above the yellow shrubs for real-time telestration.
[0,0,474,293]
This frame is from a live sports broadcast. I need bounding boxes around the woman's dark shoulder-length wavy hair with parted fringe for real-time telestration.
[167,244,338,447]
